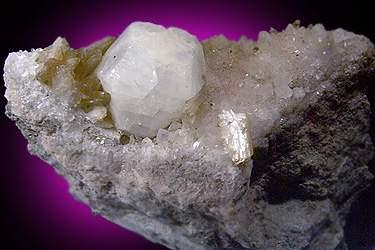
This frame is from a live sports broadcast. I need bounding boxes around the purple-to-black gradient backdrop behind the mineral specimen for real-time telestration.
[0,0,375,250]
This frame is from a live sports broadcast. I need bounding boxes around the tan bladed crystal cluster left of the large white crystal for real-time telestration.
[36,37,116,127]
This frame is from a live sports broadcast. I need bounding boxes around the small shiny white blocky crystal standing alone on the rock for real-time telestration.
[219,109,254,164]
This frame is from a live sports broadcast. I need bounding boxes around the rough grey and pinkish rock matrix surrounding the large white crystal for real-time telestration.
[4,24,374,249]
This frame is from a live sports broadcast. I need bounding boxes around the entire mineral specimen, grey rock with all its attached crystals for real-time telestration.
[4,22,375,250]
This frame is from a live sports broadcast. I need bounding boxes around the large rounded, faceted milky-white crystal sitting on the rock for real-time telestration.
[97,22,206,137]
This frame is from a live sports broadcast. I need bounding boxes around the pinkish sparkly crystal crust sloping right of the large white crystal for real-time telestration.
[194,21,373,147]
